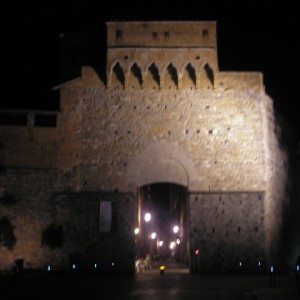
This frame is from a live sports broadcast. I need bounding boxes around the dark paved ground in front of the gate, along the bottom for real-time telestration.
[0,265,300,300]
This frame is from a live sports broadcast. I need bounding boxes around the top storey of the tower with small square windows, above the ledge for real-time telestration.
[106,21,217,51]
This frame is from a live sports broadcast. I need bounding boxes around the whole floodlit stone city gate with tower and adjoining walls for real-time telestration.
[0,21,286,272]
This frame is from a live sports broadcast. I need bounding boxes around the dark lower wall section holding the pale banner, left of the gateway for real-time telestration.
[51,193,137,272]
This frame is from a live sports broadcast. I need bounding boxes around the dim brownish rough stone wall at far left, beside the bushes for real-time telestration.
[0,169,64,270]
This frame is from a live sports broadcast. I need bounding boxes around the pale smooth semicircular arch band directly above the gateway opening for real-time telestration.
[121,142,197,192]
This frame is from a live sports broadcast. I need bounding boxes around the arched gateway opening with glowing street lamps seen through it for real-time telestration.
[135,182,188,267]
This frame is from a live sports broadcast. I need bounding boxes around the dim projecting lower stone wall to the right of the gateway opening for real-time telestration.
[189,193,267,273]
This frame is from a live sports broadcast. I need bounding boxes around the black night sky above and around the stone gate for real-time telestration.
[5,0,300,139]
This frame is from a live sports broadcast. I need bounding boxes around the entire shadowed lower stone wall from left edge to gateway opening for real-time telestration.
[0,169,137,272]
